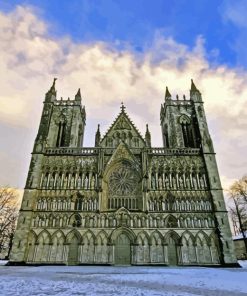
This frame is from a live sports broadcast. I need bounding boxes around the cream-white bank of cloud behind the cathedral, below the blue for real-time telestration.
[0,7,247,190]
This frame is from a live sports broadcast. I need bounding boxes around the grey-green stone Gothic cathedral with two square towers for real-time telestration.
[10,79,236,266]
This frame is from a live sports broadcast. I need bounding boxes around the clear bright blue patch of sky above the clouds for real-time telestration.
[0,0,243,67]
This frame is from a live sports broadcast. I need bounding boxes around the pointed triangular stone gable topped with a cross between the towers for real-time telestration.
[100,106,146,148]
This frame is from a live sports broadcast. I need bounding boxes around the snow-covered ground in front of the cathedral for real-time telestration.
[0,261,247,296]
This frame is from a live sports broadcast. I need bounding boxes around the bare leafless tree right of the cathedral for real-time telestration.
[229,176,247,256]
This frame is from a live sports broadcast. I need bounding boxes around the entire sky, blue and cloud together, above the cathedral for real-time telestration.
[0,0,247,188]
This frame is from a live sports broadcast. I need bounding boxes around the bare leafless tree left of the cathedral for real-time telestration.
[0,187,18,255]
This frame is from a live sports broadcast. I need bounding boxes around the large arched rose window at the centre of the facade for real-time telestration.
[103,160,142,210]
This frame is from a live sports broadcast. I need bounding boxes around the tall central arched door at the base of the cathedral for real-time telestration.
[115,233,131,265]
